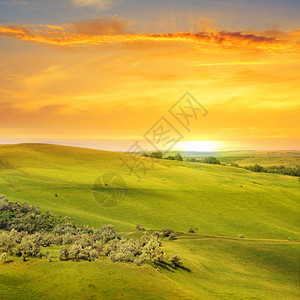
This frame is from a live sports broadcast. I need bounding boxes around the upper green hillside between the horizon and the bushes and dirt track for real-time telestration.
[0,144,300,239]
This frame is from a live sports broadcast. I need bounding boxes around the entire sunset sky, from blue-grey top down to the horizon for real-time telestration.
[0,0,300,151]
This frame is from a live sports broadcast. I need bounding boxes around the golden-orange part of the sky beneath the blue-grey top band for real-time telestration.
[0,1,300,150]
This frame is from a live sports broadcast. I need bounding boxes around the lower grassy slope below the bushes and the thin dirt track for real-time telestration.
[0,235,299,299]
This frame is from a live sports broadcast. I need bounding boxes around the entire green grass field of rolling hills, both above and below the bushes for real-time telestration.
[0,144,300,299]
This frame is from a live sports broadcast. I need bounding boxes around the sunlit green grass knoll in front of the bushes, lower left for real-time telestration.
[0,253,190,299]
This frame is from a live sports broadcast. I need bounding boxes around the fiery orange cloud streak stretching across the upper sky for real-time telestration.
[0,18,300,54]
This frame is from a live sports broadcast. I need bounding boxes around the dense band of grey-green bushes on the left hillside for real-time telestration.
[0,196,182,267]
